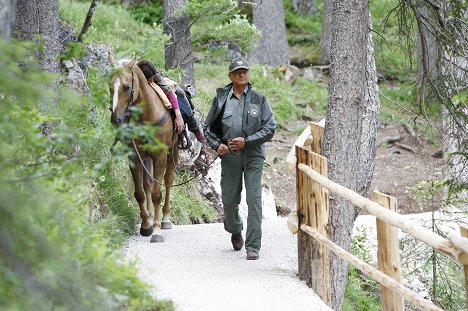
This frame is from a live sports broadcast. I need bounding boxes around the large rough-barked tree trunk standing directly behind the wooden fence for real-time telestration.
[323,0,379,310]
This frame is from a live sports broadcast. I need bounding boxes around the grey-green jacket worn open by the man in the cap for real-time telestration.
[204,83,276,158]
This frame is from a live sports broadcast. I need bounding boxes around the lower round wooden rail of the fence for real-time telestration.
[301,225,443,311]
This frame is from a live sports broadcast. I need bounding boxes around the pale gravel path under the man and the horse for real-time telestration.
[125,218,331,311]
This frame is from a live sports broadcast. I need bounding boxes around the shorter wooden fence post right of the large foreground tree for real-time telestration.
[372,191,404,311]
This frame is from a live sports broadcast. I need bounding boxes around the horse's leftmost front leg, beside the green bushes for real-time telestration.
[130,161,153,236]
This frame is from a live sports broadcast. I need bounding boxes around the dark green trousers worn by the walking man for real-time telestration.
[221,153,264,251]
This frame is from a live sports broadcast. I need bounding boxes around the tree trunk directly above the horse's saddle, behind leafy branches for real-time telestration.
[163,0,195,86]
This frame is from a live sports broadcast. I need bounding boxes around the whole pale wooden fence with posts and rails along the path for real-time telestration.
[288,123,468,311]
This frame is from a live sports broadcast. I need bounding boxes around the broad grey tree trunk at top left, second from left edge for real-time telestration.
[14,0,60,72]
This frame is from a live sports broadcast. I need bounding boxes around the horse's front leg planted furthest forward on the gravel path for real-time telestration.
[151,152,166,243]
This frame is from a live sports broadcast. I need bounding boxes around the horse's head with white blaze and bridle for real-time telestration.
[108,53,139,126]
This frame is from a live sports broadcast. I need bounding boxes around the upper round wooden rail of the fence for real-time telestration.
[298,163,468,261]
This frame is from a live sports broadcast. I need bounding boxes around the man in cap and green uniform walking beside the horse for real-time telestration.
[204,57,276,260]
